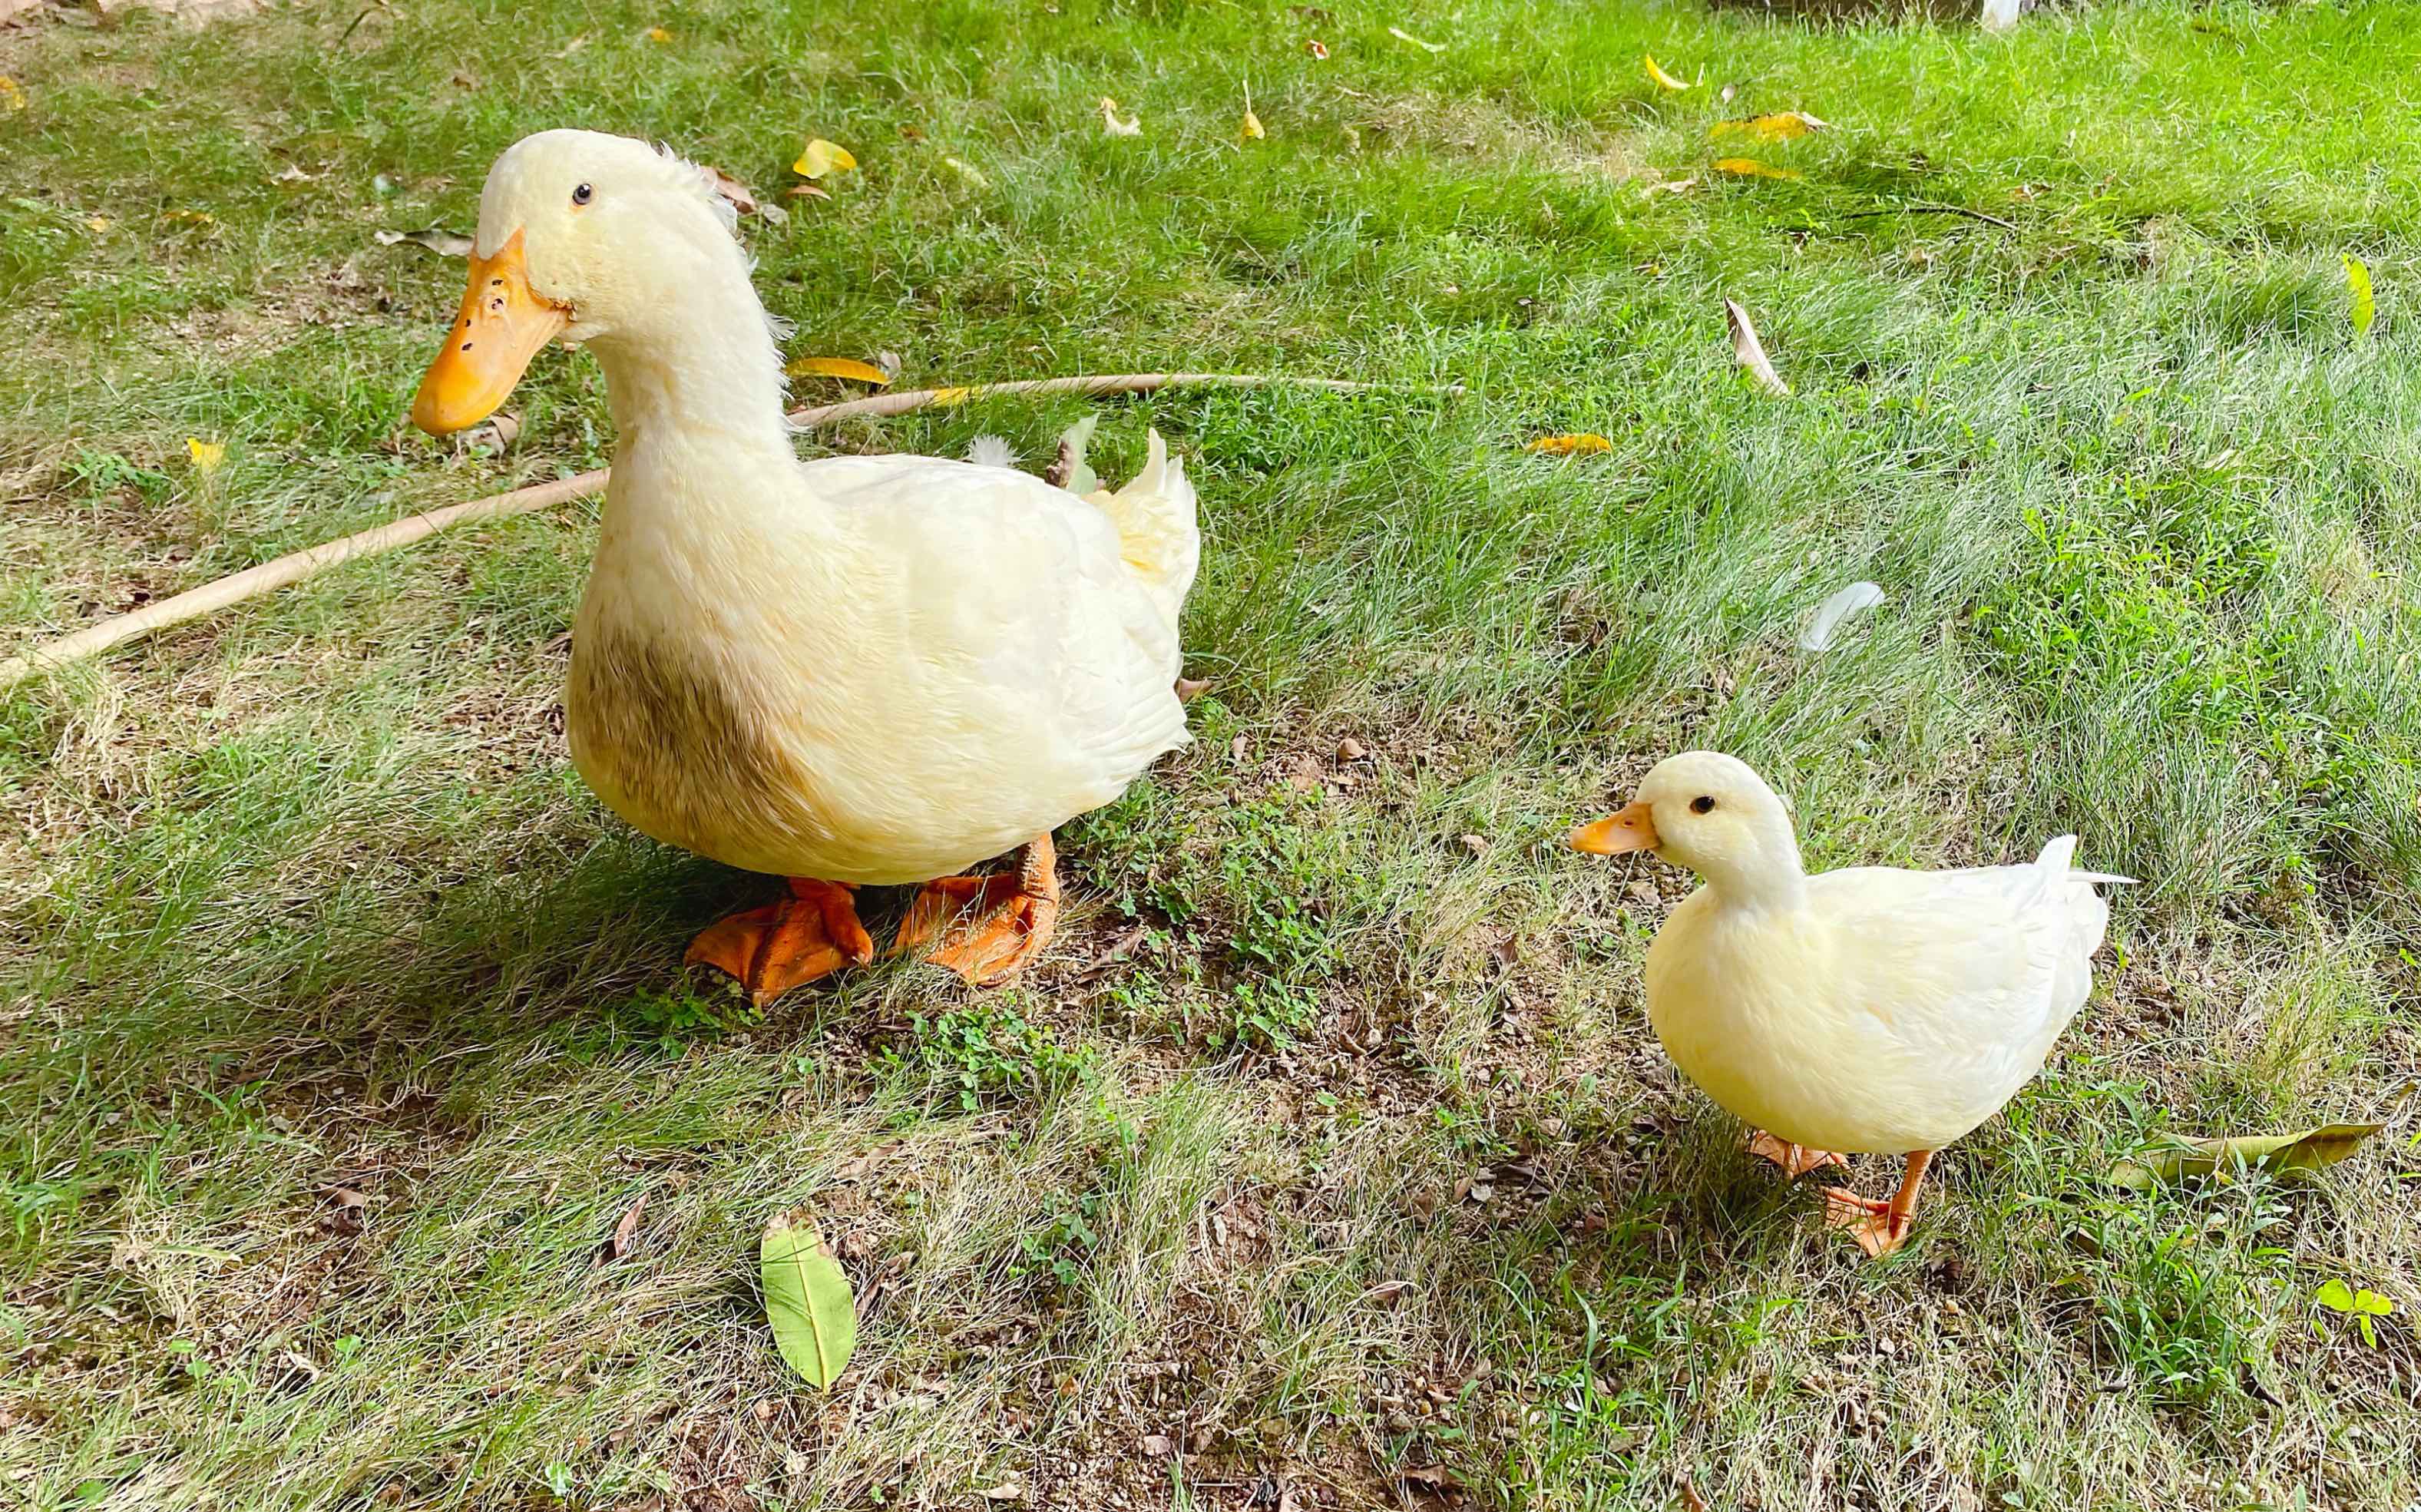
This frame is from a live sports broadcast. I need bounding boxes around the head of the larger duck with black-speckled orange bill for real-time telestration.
[412,131,779,436]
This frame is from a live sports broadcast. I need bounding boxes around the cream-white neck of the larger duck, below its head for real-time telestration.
[590,274,792,458]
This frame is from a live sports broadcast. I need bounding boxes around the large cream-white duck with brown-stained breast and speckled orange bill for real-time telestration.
[412,131,1201,1003]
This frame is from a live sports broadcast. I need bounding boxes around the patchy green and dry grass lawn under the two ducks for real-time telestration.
[0,0,2421,1512]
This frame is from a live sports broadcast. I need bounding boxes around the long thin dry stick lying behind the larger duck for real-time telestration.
[0,373,1433,690]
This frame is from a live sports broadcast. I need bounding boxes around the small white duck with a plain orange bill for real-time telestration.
[1569,751,2131,1258]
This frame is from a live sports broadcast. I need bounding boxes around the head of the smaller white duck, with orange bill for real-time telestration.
[1571,751,1804,899]
